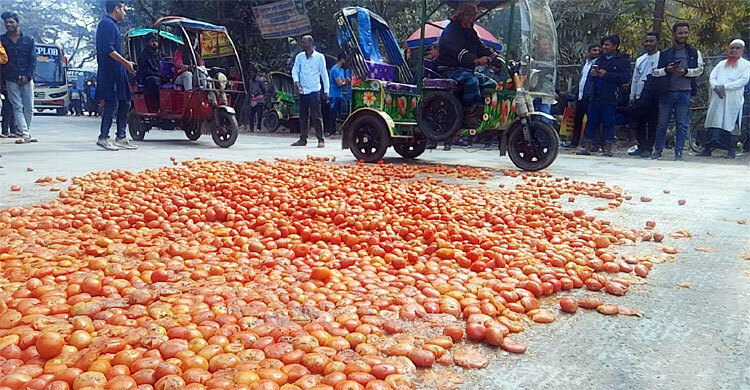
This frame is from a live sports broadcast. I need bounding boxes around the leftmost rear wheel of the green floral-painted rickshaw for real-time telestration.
[347,114,390,163]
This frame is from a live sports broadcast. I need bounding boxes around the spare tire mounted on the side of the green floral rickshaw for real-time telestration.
[417,91,463,141]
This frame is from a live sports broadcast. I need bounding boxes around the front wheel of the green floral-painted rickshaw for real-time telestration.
[508,118,560,171]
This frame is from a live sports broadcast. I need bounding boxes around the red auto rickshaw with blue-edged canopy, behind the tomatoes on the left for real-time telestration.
[127,16,245,148]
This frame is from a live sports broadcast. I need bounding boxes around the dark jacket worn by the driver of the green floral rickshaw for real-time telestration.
[437,19,492,70]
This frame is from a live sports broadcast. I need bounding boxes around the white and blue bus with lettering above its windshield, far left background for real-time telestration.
[34,44,69,115]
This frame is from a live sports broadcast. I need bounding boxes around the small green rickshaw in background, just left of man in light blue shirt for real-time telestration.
[263,72,299,133]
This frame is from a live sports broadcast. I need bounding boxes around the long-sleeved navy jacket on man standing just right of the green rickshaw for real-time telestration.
[583,51,630,106]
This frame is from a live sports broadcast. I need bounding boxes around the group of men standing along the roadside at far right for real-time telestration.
[566,22,750,161]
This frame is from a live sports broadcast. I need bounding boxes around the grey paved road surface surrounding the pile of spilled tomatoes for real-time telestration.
[0,116,750,389]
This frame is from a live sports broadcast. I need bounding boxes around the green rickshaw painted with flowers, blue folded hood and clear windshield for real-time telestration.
[334,0,560,171]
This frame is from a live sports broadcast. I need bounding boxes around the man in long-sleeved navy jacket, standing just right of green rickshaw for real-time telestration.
[577,34,630,157]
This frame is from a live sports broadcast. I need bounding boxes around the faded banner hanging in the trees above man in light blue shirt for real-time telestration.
[253,0,312,39]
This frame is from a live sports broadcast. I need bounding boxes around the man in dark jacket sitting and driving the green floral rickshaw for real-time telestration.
[438,3,495,127]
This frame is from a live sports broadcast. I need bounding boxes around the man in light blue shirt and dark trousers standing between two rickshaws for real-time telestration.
[292,35,330,148]
